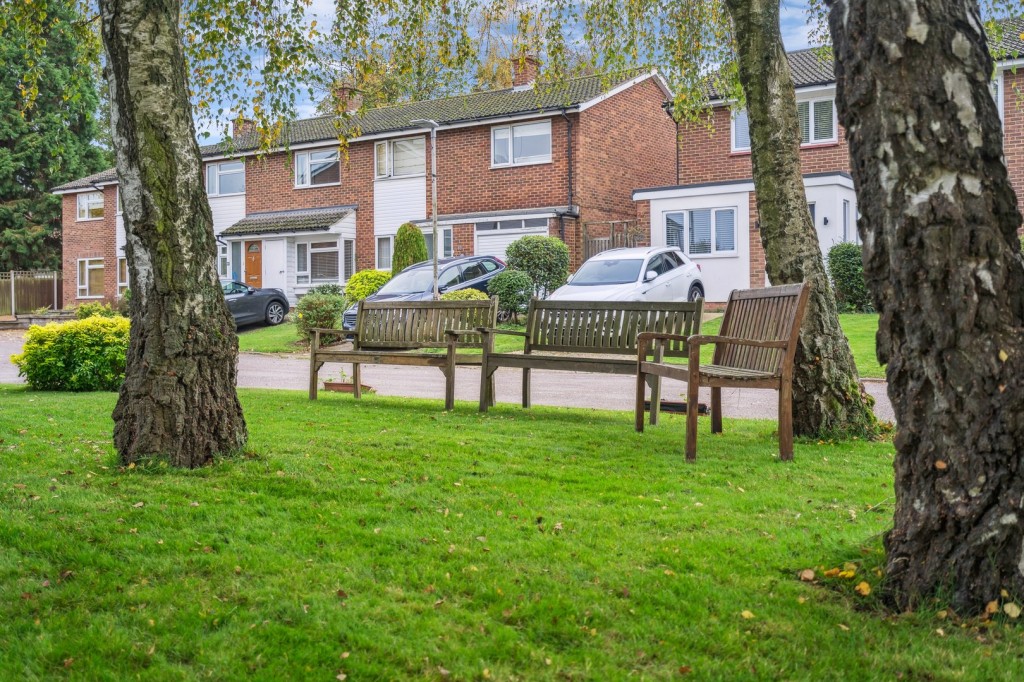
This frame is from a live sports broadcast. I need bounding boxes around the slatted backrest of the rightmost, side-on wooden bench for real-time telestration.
[712,283,810,374]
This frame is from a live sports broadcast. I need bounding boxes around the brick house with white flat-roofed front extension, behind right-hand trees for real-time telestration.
[633,29,1024,302]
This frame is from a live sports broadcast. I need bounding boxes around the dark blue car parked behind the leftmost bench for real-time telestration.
[342,256,505,331]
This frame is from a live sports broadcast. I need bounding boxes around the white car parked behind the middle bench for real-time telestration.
[549,242,705,301]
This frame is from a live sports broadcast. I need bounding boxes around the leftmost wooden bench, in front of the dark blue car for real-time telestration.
[309,298,498,410]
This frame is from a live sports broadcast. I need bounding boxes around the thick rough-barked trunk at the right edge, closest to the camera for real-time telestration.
[830,0,1024,614]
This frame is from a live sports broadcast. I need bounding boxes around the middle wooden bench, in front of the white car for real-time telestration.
[480,299,703,412]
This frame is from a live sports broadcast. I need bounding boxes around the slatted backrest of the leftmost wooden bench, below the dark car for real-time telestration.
[355,298,498,350]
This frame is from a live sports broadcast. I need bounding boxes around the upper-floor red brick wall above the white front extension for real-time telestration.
[679,102,850,186]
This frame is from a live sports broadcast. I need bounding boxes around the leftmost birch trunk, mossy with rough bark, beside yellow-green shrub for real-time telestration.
[99,0,247,467]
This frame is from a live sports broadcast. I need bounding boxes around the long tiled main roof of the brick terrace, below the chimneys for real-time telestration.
[51,69,649,191]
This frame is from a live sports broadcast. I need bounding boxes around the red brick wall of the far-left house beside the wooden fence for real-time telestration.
[60,185,119,305]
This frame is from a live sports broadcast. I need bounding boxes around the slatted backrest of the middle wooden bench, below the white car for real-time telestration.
[526,299,703,357]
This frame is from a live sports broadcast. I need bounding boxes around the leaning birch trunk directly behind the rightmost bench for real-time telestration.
[726,0,878,436]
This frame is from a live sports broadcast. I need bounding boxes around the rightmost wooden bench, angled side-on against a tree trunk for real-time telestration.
[636,284,809,462]
